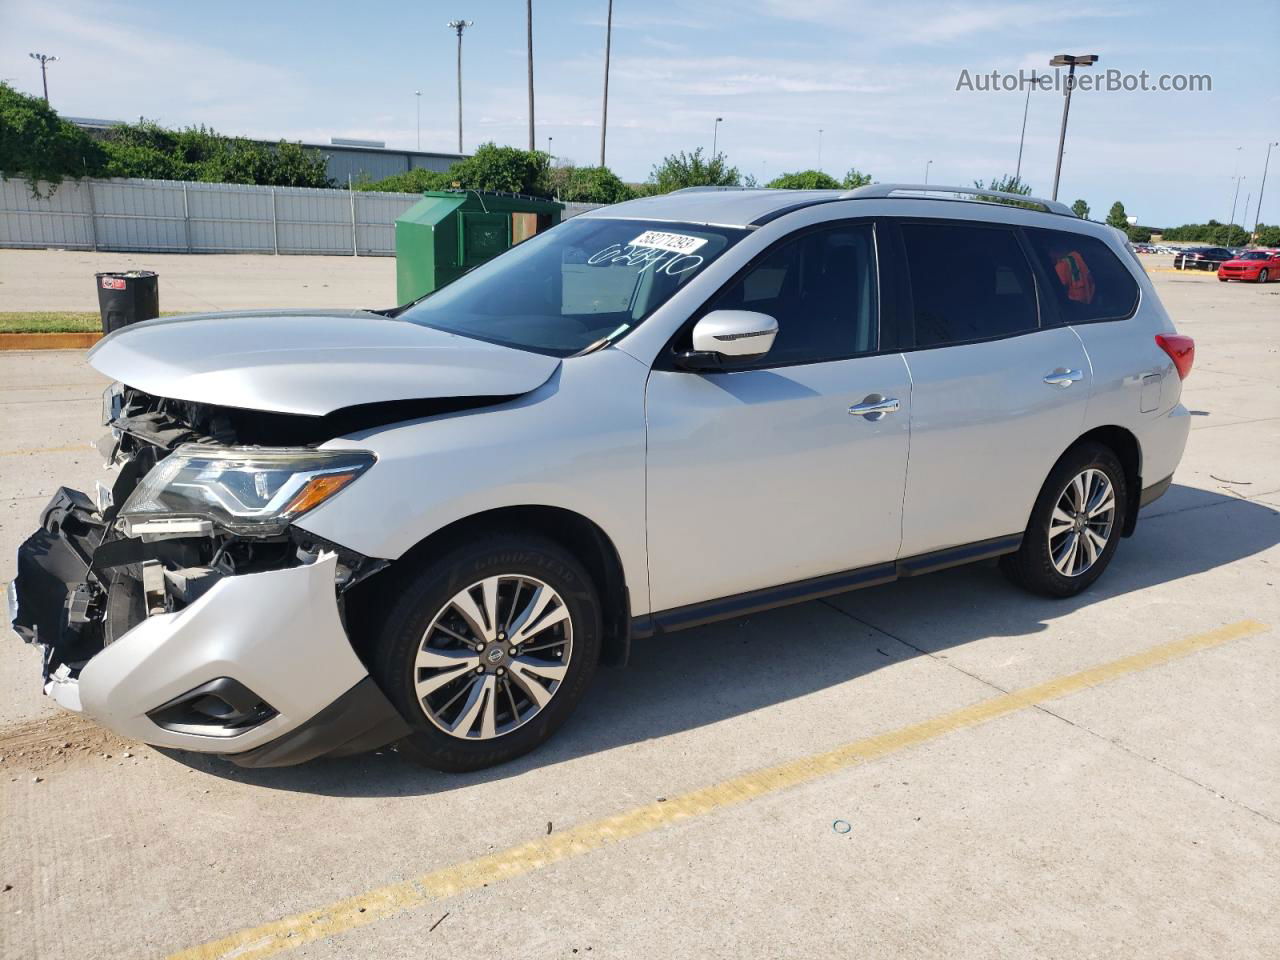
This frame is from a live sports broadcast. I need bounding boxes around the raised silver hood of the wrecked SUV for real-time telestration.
[88,310,559,416]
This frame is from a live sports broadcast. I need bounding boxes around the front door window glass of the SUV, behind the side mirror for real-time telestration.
[710,223,879,366]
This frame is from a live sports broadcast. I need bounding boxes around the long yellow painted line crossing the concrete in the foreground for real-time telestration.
[170,620,1270,960]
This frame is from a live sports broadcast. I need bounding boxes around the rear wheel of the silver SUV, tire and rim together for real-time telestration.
[1000,442,1129,596]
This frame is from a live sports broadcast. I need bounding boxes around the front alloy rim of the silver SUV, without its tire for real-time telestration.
[413,573,573,740]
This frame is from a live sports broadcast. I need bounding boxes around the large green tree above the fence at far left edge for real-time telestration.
[0,83,104,197]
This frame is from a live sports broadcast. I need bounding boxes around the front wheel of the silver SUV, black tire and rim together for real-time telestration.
[374,534,602,772]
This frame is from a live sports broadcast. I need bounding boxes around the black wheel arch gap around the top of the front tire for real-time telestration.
[346,504,631,666]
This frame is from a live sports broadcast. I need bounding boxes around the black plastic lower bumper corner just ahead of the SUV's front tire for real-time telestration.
[227,677,410,767]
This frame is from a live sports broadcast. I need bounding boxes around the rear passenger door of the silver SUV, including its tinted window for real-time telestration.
[893,220,1091,557]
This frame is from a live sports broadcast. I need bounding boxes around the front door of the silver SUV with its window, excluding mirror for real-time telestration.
[645,221,910,611]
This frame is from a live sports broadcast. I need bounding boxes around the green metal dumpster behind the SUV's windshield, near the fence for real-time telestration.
[396,189,564,303]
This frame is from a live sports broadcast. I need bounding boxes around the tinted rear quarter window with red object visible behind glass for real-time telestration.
[1027,229,1138,324]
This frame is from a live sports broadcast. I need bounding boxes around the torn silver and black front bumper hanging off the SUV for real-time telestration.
[9,488,408,767]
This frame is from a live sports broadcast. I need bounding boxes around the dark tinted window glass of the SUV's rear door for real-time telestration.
[901,223,1039,347]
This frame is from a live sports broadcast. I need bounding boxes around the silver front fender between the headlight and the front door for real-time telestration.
[297,348,649,613]
